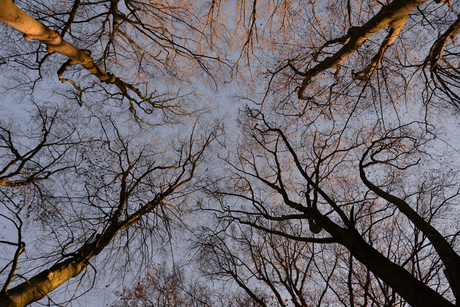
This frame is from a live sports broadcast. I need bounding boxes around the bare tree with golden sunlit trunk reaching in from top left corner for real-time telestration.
[0,0,223,120]
